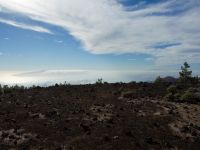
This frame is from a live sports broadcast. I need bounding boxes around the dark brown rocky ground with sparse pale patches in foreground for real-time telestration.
[0,84,200,150]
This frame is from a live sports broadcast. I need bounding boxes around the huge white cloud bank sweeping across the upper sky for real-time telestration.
[0,0,200,64]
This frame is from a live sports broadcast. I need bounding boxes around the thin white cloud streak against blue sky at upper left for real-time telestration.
[0,18,53,34]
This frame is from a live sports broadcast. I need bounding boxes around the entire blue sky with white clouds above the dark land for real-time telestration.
[0,0,200,85]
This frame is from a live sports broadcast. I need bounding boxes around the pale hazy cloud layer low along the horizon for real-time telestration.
[0,70,177,86]
